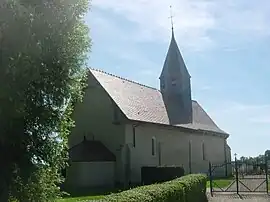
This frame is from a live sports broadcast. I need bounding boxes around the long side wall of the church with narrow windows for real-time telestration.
[126,124,228,183]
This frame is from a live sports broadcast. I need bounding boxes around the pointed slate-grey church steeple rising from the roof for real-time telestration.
[159,29,192,124]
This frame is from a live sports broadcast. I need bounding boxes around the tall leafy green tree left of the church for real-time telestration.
[0,0,91,202]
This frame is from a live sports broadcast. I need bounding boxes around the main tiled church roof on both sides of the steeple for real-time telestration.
[90,69,228,136]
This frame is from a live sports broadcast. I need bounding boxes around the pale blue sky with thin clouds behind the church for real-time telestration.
[85,0,270,157]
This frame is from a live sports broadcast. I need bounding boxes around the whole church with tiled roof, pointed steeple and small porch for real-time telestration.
[66,30,231,187]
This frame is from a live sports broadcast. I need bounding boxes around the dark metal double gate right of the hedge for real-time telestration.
[208,155,270,196]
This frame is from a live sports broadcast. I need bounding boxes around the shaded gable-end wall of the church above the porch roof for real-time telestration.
[69,77,125,181]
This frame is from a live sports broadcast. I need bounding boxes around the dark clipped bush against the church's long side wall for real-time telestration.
[141,166,185,185]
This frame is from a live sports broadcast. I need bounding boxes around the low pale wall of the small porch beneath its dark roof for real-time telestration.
[66,162,115,188]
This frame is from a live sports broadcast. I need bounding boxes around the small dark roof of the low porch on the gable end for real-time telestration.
[69,140,116,162]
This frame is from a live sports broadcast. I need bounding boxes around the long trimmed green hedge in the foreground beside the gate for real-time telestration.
[101,174,207,202]
